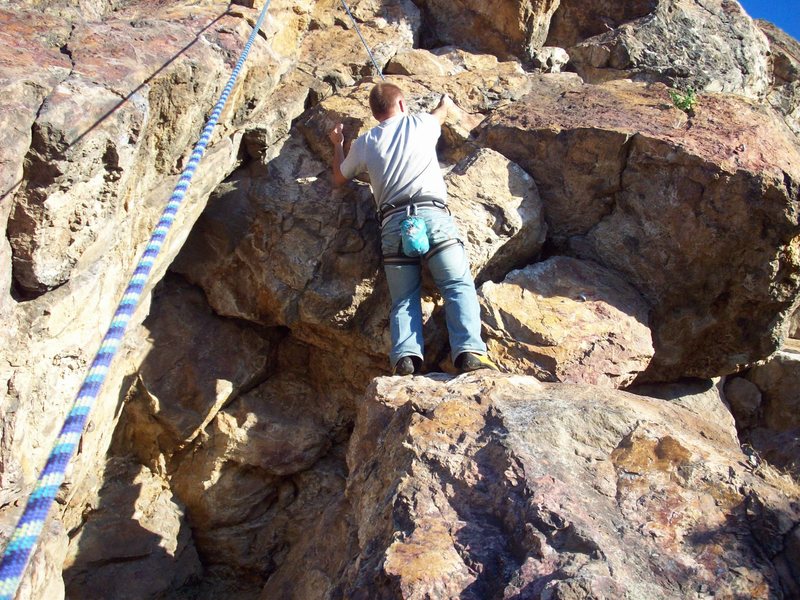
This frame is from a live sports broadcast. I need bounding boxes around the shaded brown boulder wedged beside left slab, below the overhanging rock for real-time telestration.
[117,277,277,462]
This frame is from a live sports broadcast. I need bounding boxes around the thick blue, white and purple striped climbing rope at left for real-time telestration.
[0,0,271,600]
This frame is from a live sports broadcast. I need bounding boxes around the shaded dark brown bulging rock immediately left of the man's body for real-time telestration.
[175,127,383,356]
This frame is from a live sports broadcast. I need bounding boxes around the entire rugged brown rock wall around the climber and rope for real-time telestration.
[0,0,800,600]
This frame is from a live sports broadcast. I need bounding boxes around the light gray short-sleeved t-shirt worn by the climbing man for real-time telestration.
[341,113,447,208]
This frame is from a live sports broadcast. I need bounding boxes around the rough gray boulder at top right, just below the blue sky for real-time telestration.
[560,0,770,99]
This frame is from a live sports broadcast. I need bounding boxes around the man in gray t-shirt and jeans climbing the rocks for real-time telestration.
[329,83,496,375]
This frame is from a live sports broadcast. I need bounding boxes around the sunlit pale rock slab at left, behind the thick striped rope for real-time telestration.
[0,2,392,597]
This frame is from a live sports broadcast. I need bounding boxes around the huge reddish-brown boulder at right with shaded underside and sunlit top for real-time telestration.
[479,74,800,381]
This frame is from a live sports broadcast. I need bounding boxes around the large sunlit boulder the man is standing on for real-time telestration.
[343,372,800,599]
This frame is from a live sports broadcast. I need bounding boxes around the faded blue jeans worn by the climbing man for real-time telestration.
[381,208,486,366]
